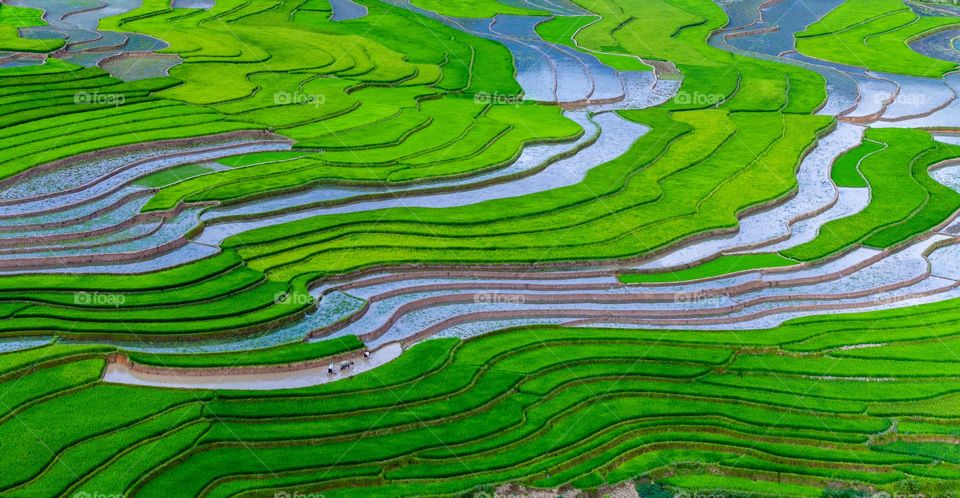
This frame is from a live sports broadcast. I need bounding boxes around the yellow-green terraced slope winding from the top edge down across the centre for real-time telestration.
[227,2,828,279]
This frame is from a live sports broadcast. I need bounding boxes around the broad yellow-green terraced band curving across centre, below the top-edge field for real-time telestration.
[232,111,829,279]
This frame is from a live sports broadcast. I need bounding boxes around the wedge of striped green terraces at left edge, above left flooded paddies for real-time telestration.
[0,68,262,178]
